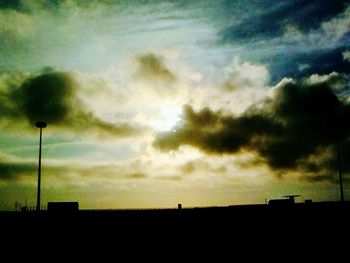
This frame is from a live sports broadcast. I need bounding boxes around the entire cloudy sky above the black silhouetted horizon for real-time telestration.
[0,0,350,210]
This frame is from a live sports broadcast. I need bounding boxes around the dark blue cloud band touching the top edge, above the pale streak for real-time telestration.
[221,0,349,42]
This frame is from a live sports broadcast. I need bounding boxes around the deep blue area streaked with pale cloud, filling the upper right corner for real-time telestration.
[219,1,350,85]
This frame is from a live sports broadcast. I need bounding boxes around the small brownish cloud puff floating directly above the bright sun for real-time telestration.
[136,53,176,82]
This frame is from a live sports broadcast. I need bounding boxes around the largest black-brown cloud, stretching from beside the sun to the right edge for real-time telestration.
[154,76,350,182]
